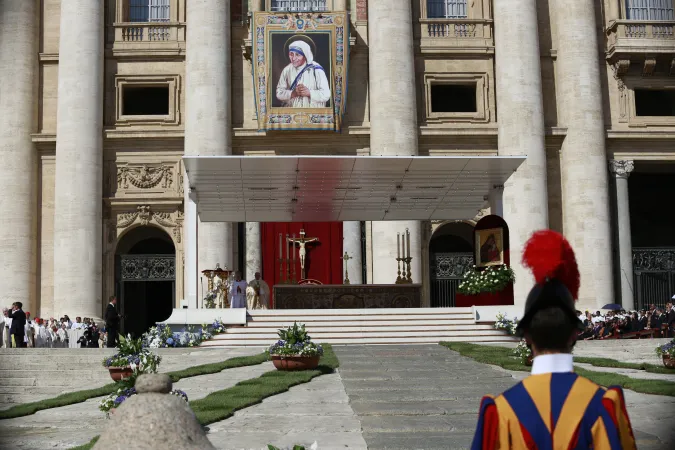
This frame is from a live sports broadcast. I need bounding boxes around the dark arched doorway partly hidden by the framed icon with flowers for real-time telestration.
[429,222,474,308]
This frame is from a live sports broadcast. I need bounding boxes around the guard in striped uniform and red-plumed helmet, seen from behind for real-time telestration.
[471,230,636,450]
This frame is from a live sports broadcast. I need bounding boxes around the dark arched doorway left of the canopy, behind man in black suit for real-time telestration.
[115,226,176,337]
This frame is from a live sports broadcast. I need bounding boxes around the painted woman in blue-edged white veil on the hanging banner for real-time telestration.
[277,40,331,108]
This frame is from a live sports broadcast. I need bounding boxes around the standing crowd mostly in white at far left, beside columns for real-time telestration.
[0,302,106,348]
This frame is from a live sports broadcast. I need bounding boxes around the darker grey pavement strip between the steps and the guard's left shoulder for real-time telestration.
[333,345,514,450]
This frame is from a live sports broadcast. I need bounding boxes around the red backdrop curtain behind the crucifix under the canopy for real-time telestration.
[260,222,343,301]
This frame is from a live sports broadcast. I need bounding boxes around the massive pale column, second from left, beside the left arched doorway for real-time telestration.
[54,0,105,317]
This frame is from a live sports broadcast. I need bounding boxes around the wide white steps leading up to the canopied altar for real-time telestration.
[202,308,514,347]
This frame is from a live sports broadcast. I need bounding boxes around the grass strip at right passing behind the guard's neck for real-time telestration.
[440,342,675,397]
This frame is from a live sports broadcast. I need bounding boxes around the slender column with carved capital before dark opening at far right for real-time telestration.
[609,161,635,311]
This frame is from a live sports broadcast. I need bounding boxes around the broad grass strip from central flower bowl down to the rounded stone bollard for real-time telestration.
[70,344,340,450]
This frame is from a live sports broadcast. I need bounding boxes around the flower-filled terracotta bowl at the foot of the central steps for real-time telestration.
[268,322,323,370]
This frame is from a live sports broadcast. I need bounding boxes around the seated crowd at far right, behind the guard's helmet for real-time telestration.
[577,302,675,340]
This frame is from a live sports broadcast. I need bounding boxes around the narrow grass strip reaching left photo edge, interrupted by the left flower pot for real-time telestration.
[0,353,267,420]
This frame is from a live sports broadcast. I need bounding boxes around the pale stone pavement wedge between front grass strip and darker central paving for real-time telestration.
[208,370,368,450]
